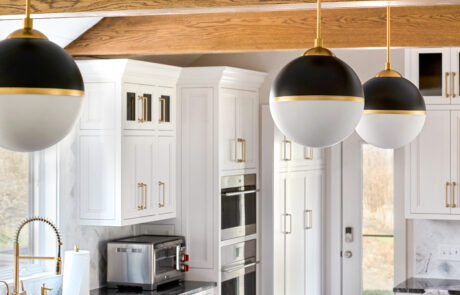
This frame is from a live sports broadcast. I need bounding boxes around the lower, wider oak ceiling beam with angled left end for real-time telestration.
[66,5,460,56]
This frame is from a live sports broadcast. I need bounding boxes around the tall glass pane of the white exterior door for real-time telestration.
[362,144,394,295]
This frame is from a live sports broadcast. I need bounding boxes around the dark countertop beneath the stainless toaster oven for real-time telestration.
[90,281,217,295]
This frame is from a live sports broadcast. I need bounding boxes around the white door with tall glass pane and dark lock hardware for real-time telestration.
[342,134,398,295]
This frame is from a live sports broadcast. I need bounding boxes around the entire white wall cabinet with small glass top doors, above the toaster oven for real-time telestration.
[77,59,180,226]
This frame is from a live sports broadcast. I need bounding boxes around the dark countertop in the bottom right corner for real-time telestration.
[393,278,460,295]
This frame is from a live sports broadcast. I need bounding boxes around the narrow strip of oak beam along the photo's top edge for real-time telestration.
[0,0,460,19]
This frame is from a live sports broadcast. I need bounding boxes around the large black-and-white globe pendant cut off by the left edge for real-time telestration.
[0,0,84,152]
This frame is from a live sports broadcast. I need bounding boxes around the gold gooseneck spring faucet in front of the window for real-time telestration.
[13,217,62,295]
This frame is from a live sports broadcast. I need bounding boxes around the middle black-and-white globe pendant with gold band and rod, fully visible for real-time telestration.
[270,0,364,147]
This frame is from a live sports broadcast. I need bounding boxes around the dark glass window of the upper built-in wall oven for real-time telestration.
[222,193,257,229]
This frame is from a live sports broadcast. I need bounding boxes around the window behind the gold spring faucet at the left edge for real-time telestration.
[0,147,58,280]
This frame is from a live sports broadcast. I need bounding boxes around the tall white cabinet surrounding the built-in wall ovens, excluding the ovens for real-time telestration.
[177,67,265,294]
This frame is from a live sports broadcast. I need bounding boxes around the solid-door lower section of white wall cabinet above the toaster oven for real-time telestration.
[77,132,176,226]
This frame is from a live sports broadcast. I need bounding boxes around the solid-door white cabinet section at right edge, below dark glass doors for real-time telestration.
[406,107,460,219]
